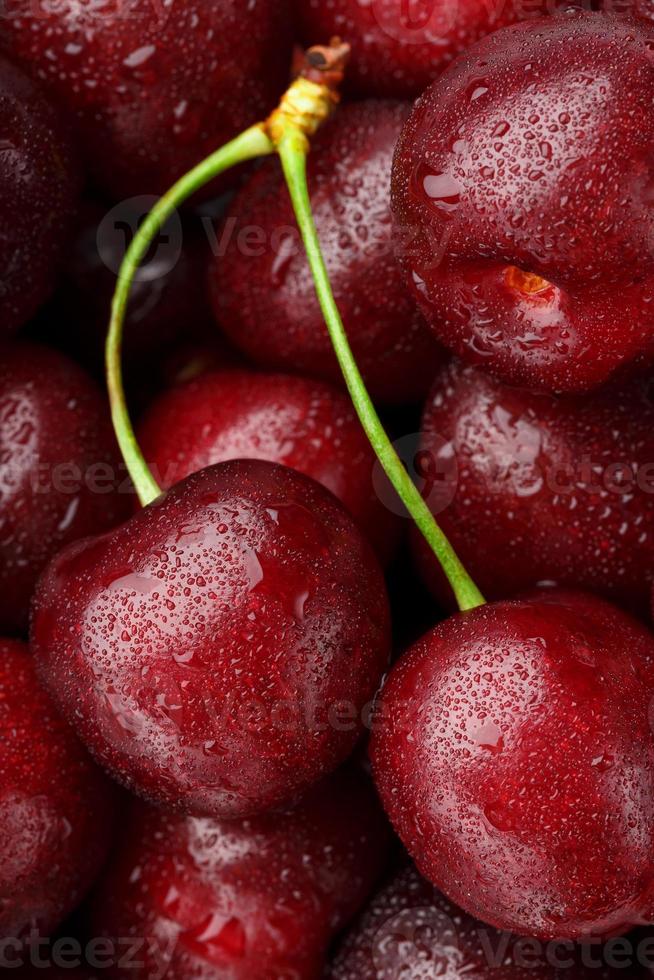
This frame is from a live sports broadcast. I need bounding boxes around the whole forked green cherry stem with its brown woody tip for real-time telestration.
[105,38,485,611]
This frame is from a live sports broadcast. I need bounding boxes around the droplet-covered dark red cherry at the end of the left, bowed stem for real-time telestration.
[32,460,389,818]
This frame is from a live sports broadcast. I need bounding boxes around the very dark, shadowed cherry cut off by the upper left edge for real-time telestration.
[0,54,79,335]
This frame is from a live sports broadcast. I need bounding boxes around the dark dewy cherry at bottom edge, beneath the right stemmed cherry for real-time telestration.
[328,867,640,980]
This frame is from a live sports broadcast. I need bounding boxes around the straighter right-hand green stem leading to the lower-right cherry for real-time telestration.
[277,129,485,611]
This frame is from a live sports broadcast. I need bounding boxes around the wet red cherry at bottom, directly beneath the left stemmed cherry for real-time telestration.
[93,770,388,980]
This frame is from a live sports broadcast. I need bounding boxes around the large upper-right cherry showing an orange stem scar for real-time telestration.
[393,12,654,391]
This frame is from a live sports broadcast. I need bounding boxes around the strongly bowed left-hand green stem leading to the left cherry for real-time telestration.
[105,124,275,507]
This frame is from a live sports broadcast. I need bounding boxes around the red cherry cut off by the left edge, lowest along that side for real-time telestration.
[0,640,115,936]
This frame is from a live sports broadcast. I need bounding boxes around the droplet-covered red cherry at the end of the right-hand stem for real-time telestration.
[370,591,654,939]
